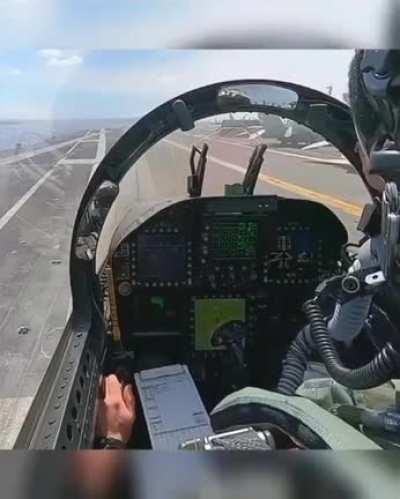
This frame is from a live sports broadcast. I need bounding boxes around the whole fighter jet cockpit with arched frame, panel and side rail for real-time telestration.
[19,80,399,450]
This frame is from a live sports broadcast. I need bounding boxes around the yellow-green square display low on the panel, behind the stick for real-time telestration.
[194,298,246,350]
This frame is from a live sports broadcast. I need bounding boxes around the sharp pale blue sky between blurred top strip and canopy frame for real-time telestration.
[0,48,354,119]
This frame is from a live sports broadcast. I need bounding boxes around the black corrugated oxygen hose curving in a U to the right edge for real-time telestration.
[303,300,400,390]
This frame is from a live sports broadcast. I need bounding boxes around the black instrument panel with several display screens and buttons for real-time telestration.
[112,196,347,350]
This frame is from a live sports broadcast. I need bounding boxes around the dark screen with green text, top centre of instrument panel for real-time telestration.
[211,222,258,258]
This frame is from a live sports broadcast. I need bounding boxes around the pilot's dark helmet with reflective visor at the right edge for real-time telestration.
[349,50,400,190]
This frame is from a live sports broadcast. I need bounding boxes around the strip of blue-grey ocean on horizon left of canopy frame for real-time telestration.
[0,118,137,151]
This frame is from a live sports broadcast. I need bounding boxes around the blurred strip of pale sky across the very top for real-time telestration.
[0,0,399,50]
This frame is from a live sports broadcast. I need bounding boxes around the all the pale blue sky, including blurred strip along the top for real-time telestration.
[0,0,394,119]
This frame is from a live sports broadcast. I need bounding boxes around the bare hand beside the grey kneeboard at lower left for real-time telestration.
[96,374,136,444]
